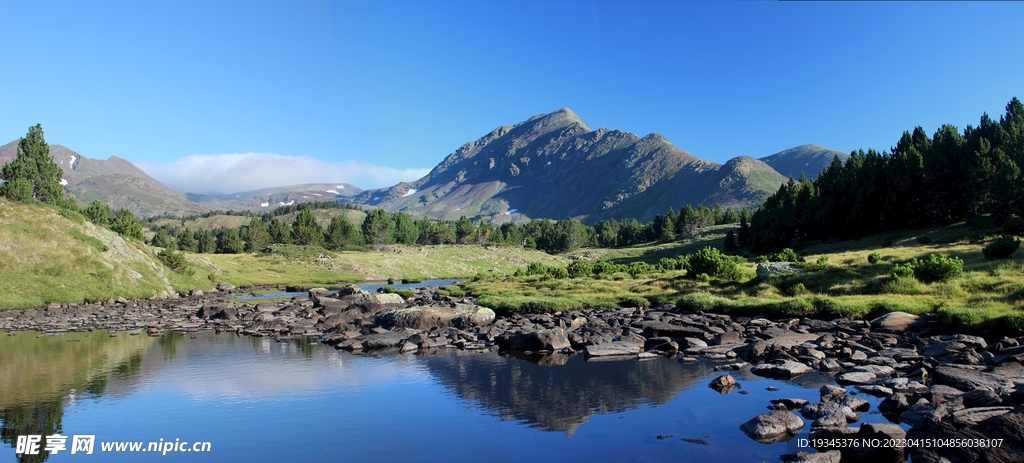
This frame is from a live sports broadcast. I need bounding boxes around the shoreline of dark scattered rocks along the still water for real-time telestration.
[0,284,1024,462]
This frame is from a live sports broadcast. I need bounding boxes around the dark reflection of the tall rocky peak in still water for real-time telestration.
[422,352,714,435]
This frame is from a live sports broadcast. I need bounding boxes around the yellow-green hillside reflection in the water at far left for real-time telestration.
[0,332,154,462]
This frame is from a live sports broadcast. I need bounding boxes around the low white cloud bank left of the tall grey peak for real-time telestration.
[138,153,430,195]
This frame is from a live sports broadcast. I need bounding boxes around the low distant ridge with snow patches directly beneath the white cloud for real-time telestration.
[185,183,362,211]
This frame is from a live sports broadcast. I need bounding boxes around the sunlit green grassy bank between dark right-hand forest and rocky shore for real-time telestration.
[460,217,1024,332]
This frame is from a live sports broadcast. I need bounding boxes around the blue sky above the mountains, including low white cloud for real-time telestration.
[0,0,1024,193]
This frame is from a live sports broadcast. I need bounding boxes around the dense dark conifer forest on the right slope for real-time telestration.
[737,97,1024,253]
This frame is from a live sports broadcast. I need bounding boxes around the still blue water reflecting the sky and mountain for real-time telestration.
[0,332,909,462]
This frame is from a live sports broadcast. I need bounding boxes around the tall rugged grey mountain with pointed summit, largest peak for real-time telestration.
[352,109,785,223]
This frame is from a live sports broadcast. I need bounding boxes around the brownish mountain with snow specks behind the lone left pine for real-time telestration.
[0,140,209,217]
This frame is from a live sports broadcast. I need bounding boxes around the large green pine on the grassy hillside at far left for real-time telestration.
[0,124,65,205]
